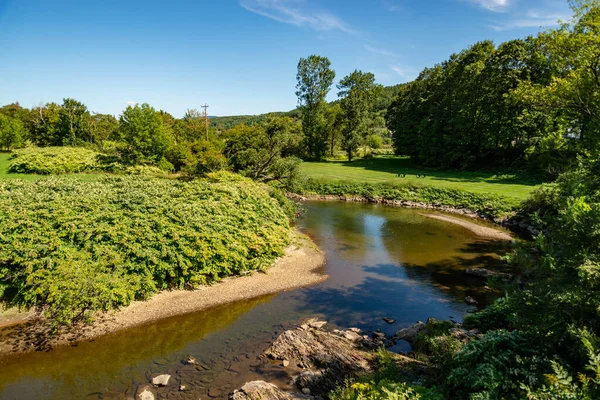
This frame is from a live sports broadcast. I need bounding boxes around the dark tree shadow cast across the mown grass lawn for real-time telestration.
[329,156,542,186]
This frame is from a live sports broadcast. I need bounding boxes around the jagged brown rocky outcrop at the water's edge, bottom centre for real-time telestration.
[230,319,427,400]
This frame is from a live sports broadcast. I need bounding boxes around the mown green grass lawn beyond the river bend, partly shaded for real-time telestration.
[301,156,542,200]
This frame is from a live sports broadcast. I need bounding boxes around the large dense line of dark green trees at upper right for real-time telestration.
[386,1,600,177]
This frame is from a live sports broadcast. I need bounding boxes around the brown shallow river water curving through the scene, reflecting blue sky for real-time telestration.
[0,202,506,399]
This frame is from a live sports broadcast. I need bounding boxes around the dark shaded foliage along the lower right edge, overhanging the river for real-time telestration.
[447,152,600,399]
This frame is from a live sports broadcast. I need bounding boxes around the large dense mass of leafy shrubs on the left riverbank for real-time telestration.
[0,173,289,324]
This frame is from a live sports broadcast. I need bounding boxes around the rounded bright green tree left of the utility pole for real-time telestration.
[119,103,173,164]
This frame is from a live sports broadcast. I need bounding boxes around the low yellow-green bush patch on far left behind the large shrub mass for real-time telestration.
[8,147,101,175]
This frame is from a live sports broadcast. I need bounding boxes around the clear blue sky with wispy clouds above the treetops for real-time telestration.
[0,0,570,117]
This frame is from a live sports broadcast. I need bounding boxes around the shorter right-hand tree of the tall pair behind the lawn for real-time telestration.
[337,70,383,161]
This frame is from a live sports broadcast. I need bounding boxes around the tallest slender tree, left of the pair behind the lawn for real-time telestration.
[296,55,335,160]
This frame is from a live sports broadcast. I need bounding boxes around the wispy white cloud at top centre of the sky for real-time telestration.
[240,0,353,33]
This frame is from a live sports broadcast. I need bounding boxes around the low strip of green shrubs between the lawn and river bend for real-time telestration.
[293,179,520,217]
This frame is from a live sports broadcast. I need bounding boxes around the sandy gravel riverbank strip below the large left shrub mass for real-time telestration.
[0,231,327,355]
